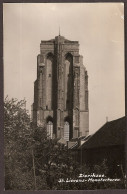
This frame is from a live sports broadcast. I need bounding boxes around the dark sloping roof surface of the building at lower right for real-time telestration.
[78,117,126,149]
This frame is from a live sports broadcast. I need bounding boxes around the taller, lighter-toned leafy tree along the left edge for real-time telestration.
[4,97,33,189]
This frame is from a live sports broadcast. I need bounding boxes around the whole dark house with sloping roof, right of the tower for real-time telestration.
[72,117,126,175]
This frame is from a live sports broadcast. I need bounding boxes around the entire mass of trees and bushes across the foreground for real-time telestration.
[4,97,124,190]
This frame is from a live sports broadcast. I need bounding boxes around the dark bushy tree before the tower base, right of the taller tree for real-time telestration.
[31,128,78,190]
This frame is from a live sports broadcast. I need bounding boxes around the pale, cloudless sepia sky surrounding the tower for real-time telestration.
[3,3,125,134]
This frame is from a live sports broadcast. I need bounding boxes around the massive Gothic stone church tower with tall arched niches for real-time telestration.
[32,35,89,141]
